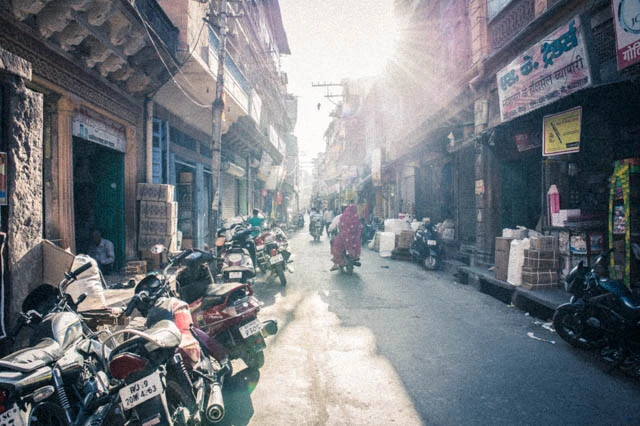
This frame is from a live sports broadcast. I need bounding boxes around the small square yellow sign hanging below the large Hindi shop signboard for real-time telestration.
[542,107,582,157]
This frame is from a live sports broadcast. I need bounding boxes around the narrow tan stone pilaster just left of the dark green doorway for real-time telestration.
[52,97,76,253]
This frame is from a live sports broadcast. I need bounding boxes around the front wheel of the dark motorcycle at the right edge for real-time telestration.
[553,305,602,349]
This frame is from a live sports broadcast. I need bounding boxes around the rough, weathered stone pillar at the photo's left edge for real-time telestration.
[0,61,43,329]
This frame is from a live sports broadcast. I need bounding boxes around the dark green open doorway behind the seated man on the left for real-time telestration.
[73,137,125,270]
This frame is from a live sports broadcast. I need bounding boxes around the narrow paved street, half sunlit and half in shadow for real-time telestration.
[223,230,640,425]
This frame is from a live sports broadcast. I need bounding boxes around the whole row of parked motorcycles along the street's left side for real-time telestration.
[0,218,291,426]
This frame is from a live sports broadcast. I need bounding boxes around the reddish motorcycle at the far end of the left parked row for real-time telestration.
[255,226,293,286]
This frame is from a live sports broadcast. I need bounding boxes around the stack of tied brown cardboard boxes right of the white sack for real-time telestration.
[522,235,560,290]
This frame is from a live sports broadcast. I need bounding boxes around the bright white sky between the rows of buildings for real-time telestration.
[280,0,395,168]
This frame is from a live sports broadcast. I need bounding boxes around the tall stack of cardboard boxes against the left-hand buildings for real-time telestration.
[137,183,178,263]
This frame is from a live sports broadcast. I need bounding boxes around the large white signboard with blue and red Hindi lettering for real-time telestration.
[497,16,592,121]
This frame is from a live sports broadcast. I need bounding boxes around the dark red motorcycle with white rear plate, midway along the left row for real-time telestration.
[151,248,278,369]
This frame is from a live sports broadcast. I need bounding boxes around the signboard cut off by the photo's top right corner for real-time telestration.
[611,0,640,70]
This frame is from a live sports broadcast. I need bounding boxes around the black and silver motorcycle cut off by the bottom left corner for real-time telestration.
[0,263,110,426]
